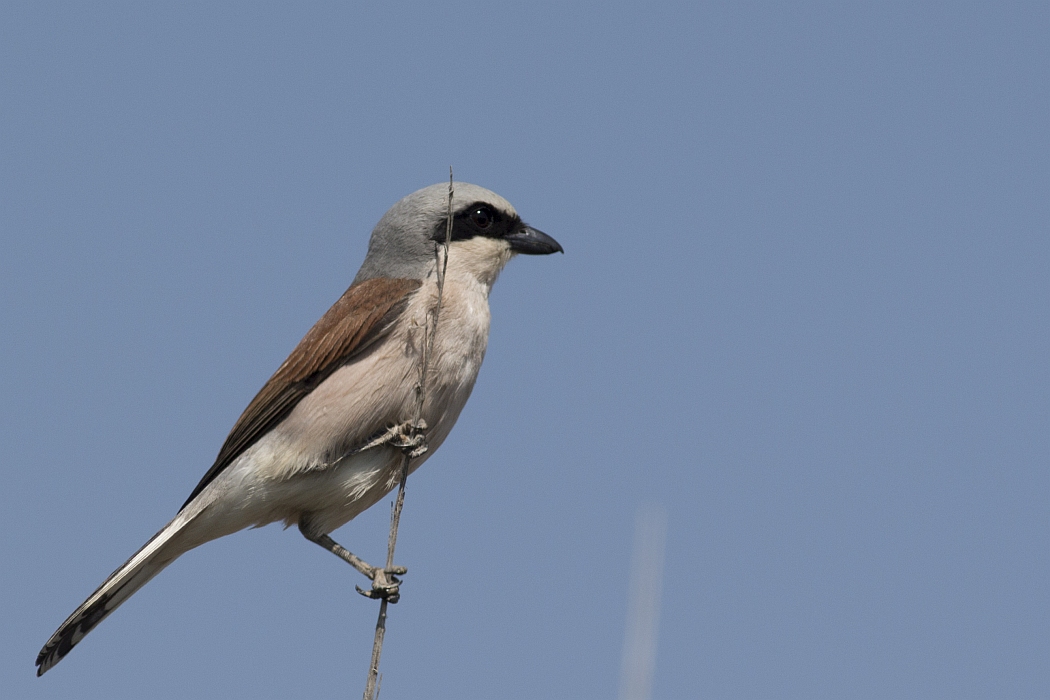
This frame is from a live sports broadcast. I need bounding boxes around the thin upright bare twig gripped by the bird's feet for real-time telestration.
[364,166,455,700]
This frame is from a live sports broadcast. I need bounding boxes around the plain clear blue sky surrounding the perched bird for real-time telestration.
[0,2,1050,700]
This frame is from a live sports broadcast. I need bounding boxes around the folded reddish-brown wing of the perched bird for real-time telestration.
[183,277,421,508]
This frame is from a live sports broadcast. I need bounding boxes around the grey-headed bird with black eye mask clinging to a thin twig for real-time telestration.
[36,183,564,676]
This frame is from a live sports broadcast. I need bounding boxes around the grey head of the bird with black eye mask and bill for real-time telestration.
[354,183,564,284]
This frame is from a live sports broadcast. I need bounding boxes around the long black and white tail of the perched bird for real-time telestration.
[37,512,192,676]
